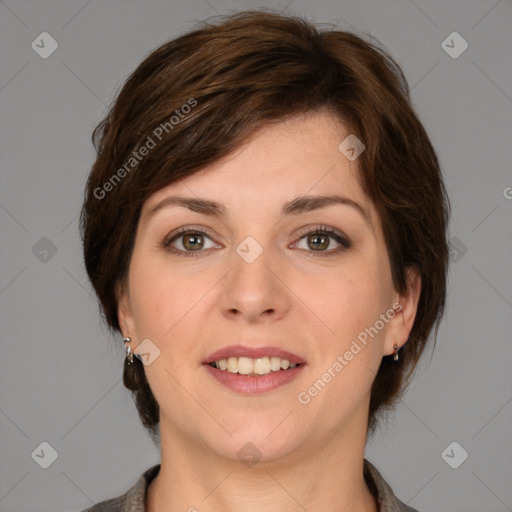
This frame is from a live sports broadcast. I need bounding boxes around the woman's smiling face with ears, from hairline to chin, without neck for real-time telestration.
[119,113,419,460]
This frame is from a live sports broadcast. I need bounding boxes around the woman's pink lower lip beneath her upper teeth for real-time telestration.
[203,364,305,395]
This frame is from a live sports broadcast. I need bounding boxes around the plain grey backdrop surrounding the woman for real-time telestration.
[0,0,512,512]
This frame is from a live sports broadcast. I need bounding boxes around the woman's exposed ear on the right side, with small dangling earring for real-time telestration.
[384,266,421,355]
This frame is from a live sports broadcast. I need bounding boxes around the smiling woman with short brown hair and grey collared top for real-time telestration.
[81,11,449,512]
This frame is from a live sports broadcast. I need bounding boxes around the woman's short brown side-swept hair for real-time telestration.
[80,11,450,434]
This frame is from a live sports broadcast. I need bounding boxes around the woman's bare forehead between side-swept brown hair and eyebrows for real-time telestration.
[143,113,376,230]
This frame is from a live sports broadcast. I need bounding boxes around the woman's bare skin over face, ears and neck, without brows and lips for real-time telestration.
[118,112,421,512]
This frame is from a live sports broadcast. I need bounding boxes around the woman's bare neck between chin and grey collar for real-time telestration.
[146,416,378,512]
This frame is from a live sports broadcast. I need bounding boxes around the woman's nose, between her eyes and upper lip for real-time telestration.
[220,239,290,323]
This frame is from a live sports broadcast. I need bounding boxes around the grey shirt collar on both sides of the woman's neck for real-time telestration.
[82,459,418,512]
